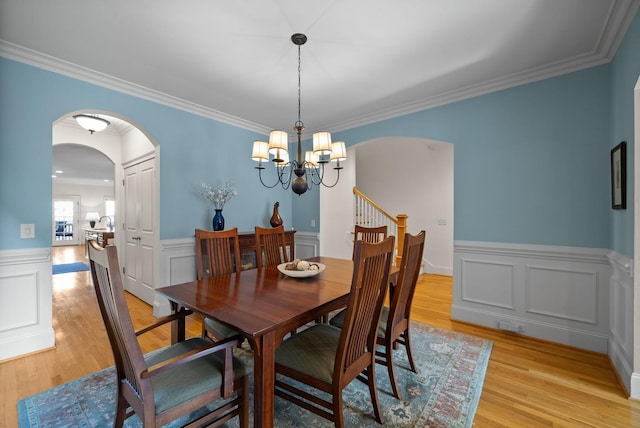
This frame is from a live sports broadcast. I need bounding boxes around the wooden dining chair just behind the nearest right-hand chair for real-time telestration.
[329,230,426,399]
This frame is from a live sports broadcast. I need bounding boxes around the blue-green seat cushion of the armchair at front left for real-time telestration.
[145,337,248,414]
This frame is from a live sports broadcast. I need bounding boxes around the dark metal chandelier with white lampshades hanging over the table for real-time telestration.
[251,33,347,195]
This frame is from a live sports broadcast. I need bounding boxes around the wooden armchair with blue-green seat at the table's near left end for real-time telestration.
[87,240,249,428]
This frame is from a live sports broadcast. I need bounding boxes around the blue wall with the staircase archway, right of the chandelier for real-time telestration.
[322,66,610,248]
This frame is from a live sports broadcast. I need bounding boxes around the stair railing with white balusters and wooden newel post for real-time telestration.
[353,187,408,266]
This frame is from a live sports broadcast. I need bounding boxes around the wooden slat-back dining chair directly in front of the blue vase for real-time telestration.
[196,227,242,341]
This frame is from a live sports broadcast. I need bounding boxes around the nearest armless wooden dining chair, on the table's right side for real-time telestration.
[275,236,395,428]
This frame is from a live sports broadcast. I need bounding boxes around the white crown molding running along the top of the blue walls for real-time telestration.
[0,0,640,139]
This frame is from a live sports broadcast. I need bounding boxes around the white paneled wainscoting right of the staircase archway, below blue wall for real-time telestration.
[451,241,612,354]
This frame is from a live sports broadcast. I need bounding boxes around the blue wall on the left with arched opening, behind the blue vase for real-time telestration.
[0,58,293,250]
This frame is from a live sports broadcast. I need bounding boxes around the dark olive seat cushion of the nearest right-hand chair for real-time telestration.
[276,324,341,383]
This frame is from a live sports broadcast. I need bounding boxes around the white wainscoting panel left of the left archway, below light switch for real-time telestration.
[0,248,55,361]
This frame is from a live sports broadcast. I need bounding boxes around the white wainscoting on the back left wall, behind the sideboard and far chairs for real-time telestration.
[153,232,320,317]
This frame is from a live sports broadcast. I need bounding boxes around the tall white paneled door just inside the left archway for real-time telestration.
[124,158,155,305]
